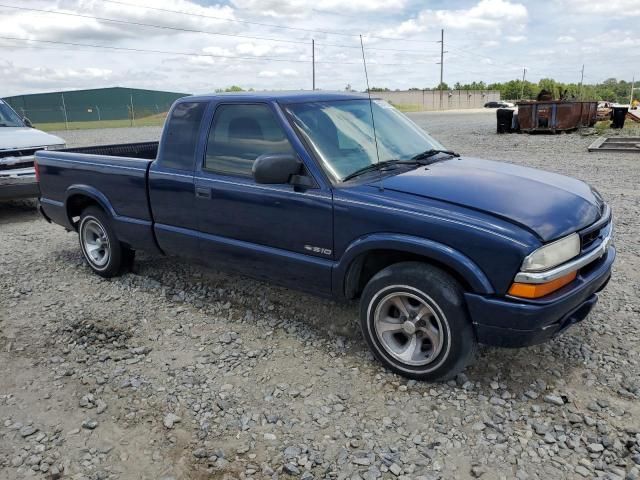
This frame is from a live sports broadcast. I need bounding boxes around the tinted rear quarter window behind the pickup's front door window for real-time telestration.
[160,102,207,171]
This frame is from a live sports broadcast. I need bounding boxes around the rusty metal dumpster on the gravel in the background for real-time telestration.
[517,100,598,133]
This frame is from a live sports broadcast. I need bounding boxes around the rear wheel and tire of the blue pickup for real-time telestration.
[78,207,135,278]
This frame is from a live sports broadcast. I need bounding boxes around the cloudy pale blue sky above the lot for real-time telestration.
[0,0,640,97]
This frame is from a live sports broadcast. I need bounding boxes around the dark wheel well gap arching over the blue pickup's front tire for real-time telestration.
[344,250,472,299]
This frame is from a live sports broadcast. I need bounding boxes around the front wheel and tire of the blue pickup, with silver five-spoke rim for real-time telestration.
[360,262,478,381]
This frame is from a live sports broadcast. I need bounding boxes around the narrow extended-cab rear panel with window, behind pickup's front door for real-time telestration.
[149,101,208,257]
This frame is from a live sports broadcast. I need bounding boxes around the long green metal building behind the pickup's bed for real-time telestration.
[3,87,189,123]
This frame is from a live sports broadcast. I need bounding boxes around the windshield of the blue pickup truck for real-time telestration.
[286,99,444,181]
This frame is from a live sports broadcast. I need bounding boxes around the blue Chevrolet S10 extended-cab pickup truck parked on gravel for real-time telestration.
[36,92,615,380]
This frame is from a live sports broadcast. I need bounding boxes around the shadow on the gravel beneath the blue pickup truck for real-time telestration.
[125,254,593,395]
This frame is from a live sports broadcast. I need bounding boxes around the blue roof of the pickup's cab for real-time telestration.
[181,90,368,103]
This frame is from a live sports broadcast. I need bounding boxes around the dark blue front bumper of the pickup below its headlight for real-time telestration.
[465,245,616,347]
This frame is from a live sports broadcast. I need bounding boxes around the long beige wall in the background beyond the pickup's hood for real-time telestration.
[375,90,500,111]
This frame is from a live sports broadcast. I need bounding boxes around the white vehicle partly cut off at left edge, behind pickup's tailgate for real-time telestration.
[0,100,66,201]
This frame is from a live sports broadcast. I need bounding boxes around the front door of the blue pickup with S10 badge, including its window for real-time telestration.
[195,103,333,293]
